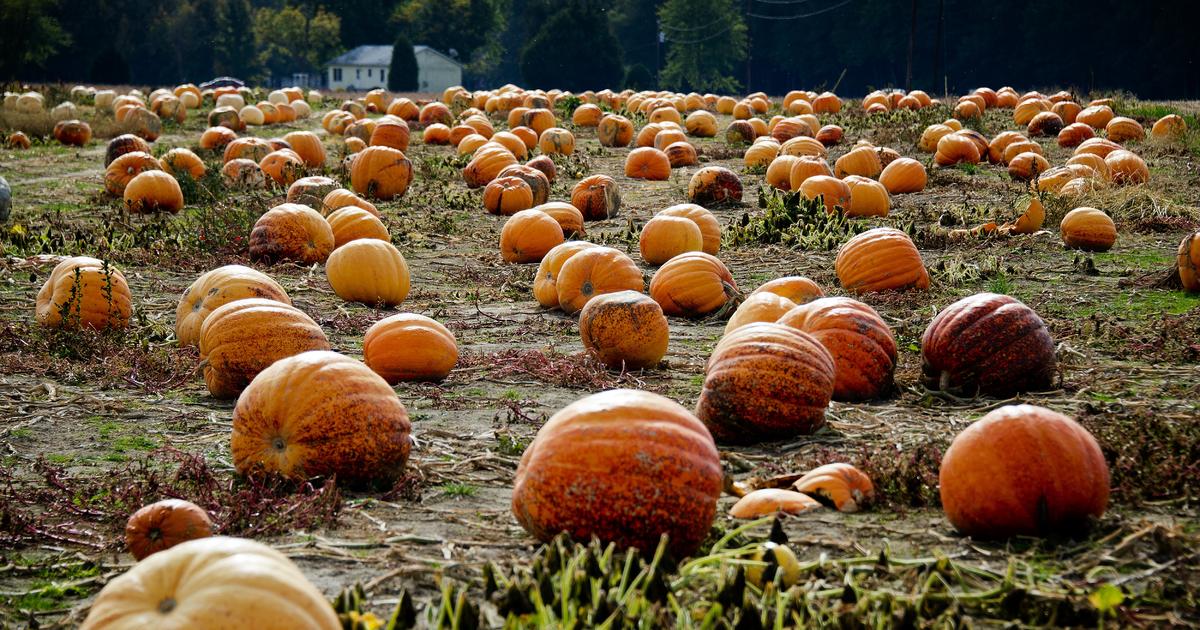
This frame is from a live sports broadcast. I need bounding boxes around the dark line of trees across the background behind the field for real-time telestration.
[0,0,1200,98]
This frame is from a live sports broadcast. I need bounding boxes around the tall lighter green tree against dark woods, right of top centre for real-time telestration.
[659,0,746,92]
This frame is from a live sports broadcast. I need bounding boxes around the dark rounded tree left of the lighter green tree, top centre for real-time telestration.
[521,0,625,91]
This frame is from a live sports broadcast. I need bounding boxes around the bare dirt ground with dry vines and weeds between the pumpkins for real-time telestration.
[0,87,1200,628]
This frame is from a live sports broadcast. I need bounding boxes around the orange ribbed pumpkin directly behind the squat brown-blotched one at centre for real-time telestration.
[554,247,644,314]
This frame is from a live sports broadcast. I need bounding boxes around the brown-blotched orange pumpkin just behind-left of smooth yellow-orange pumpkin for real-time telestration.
[250,204,334,264]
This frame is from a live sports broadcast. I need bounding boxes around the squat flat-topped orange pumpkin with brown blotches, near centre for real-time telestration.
[580,290,670,370]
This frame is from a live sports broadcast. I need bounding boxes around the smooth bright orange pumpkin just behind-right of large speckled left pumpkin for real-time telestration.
[362,313,458,385]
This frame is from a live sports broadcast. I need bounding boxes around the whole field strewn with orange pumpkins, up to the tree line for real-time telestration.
[0,84,1200,629]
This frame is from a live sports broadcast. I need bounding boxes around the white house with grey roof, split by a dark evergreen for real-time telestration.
[325,46,462,92]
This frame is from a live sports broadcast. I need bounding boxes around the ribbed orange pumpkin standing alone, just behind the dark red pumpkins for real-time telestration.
[834,228,929,293]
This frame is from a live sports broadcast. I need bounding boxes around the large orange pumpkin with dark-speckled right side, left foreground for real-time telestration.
[230,352,412,484]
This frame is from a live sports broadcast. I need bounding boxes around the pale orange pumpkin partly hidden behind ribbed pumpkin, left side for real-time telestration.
[175,265,292,346]
